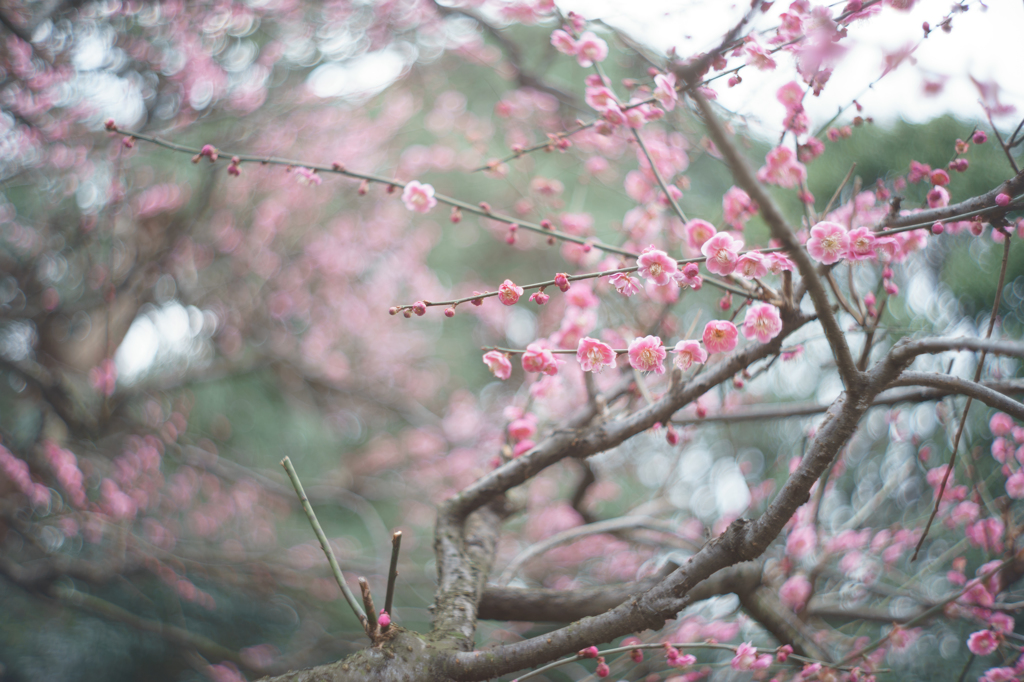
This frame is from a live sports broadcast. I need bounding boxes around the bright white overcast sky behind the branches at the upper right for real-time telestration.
[558,0,1024,130]
